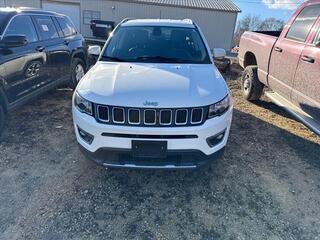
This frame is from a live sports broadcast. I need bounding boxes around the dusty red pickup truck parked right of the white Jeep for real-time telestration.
[239,0,320,135]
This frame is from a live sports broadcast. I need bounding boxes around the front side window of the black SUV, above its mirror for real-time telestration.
[5,16,38,43]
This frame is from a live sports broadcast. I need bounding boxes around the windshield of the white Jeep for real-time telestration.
[101,26,211,64]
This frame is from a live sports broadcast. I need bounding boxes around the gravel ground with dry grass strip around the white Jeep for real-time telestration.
[0,64,320,240]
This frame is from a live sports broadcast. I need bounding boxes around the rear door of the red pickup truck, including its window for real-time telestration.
[268,5,320,100]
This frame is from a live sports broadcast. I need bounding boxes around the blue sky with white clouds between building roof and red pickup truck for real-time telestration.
[234,0,304,21]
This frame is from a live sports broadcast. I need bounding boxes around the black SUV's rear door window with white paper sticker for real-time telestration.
[34,16,59,40]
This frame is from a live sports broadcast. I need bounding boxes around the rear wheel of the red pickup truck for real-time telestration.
[241,66,264,101]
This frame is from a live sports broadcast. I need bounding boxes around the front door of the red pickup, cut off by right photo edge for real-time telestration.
[292,21,320,121]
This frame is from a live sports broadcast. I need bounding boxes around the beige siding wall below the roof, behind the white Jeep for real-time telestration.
[81,0,237,49]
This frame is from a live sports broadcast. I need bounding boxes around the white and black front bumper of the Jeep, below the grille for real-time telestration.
[72,107,233,169]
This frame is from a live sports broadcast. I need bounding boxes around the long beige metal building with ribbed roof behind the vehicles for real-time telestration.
[0,0,240,49]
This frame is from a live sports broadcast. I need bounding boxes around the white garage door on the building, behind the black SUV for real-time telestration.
[42,2,81,31]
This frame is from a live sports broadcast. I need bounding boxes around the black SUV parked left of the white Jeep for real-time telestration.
[0,8,88,134]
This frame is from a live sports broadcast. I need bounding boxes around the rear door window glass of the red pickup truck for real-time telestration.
[286,4,320,42]
